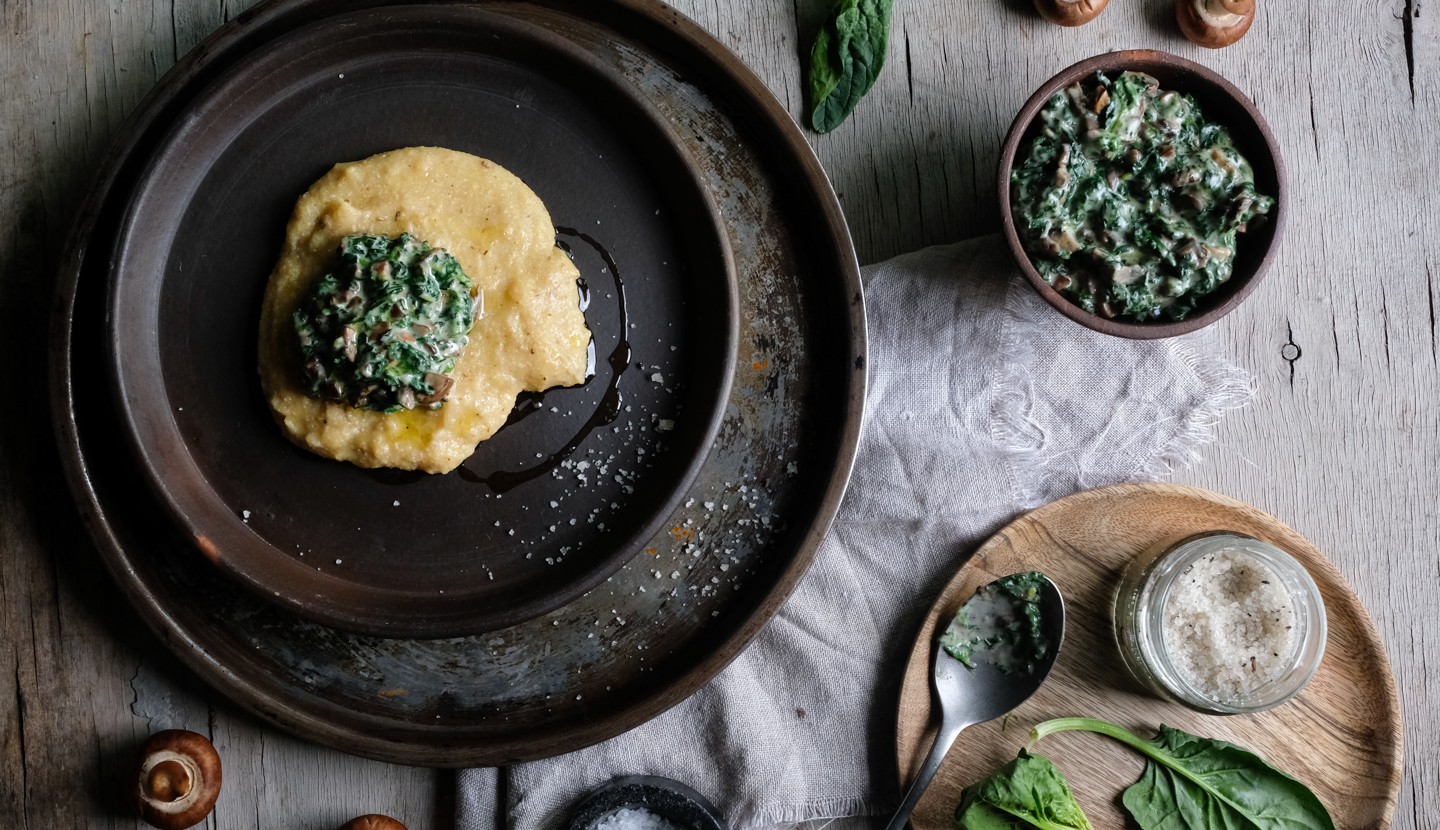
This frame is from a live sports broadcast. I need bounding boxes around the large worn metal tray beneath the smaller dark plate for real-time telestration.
[52,0,865,767]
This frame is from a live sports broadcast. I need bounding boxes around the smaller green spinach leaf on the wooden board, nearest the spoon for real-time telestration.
[955,749,1090,830]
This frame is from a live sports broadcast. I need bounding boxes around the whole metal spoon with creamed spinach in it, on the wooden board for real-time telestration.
[886,571,1066,830]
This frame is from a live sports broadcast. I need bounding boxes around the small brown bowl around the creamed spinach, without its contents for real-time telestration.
[998,49,1289,340]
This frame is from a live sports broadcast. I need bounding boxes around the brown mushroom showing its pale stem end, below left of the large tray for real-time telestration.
[135,729,220,830]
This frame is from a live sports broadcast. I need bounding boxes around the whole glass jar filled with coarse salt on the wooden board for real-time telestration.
[1115,530,1325,715]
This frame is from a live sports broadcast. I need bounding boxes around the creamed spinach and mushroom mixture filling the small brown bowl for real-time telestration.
[1011,72,1274,323]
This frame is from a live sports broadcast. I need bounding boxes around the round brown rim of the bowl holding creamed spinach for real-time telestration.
[996,49,1289,340]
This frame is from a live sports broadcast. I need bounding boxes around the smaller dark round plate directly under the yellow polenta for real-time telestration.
[109,6,736,637]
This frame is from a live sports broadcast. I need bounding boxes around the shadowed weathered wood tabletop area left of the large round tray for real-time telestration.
[0,0,451,830]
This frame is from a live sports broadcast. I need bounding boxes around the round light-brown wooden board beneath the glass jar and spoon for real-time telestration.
[896,484,1401,830]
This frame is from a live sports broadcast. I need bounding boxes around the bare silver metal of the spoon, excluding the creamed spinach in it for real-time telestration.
[886,578,1066,830]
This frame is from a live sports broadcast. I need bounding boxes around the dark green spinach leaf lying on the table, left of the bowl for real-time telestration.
[809,0,891,133]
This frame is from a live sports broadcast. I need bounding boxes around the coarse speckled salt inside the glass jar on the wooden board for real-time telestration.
[1164,550,1296,703]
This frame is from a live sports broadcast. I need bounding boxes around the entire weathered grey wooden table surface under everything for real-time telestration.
[0,0,1440,830]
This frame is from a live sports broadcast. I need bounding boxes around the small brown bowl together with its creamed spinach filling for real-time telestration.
[999,52,1283,339]
